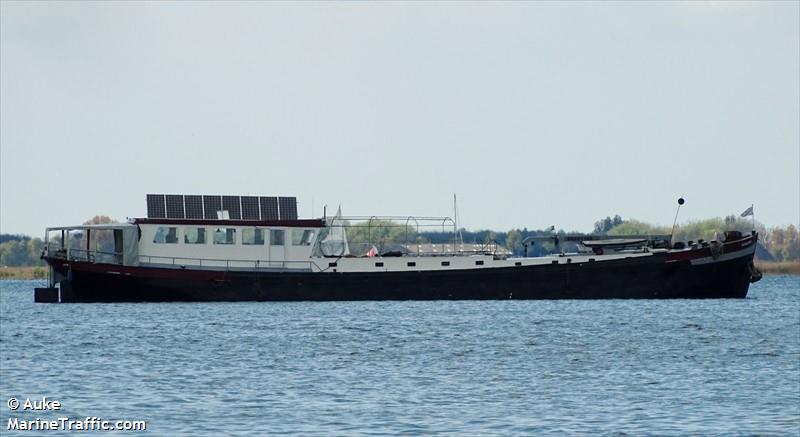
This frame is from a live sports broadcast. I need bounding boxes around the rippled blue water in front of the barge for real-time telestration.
[0,276,800,435]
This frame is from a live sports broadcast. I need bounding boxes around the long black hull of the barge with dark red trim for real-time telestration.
[42,247,753,302]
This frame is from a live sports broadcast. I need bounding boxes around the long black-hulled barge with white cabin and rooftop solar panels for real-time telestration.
[34,194,761,303]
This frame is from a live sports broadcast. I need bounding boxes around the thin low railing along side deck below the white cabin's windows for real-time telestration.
[139,255,319,270]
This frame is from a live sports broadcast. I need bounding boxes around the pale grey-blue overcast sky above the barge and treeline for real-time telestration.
[0,1,800,235]
